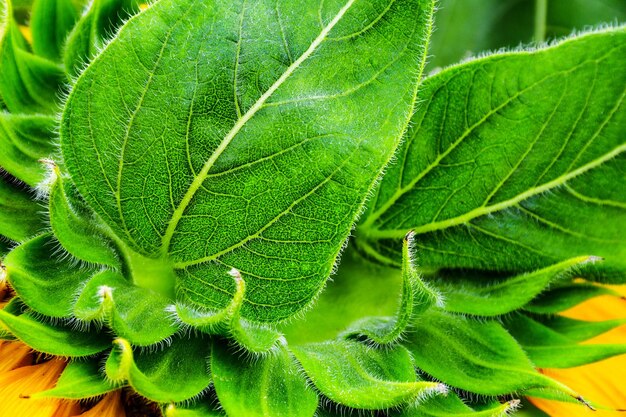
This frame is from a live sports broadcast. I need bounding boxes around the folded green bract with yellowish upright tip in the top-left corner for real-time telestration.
[0,0,65,114]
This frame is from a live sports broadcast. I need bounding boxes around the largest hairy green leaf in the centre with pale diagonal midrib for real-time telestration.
[61,0,433,321]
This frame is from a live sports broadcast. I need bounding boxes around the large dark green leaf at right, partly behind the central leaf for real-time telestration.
[357,28,626,280]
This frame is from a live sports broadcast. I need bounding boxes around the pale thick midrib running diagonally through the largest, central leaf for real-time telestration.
[161,0,355,257]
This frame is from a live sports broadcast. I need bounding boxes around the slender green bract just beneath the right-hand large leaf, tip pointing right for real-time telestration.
[432,256,595,316]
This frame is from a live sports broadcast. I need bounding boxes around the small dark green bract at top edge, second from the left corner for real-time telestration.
[30,0,78,61]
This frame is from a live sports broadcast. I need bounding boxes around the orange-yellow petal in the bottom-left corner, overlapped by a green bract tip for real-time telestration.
[0,359,80,417]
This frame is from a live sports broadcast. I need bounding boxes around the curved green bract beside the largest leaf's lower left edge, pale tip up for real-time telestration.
[49,171,120,268]
